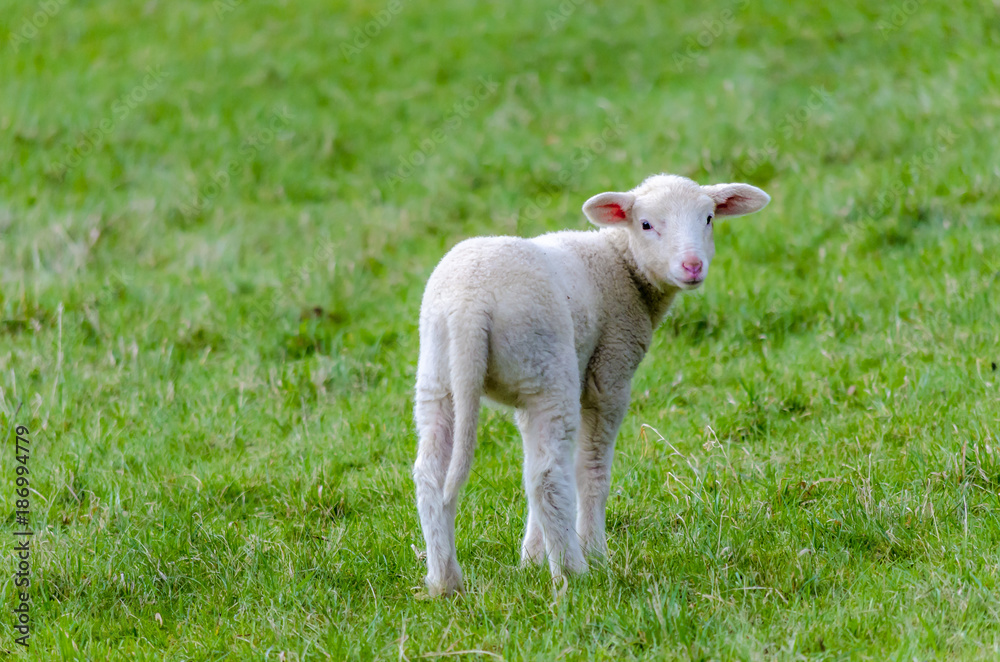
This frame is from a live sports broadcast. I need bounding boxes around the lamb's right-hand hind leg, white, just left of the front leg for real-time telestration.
[517,398,587,577]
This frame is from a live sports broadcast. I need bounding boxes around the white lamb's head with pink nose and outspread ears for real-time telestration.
[583,175,771,290]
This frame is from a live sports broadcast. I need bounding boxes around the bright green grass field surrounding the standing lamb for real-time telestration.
[0,0,1000,660]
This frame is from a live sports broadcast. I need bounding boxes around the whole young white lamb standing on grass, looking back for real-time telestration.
[413,175,771,596]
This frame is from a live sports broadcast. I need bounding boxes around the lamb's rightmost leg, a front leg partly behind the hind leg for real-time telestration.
[576,392,628,558]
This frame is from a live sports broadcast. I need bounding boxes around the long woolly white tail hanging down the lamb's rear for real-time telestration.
[444,313,490,503]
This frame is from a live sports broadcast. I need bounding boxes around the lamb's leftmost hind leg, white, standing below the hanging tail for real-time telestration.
[413,389,464,595]
